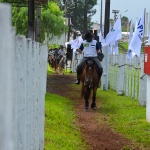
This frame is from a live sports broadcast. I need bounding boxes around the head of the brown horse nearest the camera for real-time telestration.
[84,59,95,86]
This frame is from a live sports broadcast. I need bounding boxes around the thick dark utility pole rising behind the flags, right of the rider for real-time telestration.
[104,0,110,38]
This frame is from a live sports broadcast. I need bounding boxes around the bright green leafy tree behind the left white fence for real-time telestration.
[12,2,67,41]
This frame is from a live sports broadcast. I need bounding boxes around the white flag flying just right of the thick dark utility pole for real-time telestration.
[106,17,122,44]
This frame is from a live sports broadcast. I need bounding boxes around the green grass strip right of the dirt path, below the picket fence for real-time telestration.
[97,90,150,149]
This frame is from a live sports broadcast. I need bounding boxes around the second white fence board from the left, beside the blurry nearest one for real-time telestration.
[15,36,26,150]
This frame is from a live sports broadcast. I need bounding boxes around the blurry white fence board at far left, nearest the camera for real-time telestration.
[0,3,16,150]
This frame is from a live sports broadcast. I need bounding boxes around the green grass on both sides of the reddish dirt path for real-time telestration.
[45,64,150,150]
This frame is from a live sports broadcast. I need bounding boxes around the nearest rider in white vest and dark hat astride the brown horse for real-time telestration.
[75,32,103,87]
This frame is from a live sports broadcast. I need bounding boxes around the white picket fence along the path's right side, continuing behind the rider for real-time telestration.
[72,47,150,122]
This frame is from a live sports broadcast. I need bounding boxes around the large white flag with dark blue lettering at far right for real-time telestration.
[129,10,144,58]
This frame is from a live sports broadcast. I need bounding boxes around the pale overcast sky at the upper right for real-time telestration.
[92,0,150,23]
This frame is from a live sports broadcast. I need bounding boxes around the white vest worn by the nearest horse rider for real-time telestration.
[83,40,97,57]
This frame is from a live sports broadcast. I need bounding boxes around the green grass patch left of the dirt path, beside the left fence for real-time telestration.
[44,93,86,150]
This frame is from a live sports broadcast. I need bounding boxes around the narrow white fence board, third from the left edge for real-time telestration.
[25,39,34,150]
